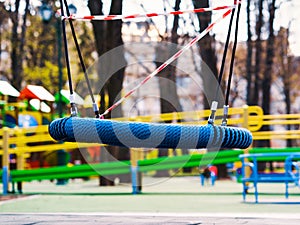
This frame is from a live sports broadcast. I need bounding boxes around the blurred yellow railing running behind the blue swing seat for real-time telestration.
[0,106,300,169]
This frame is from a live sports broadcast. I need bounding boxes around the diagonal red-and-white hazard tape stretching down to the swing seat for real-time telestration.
[100,9,232,118]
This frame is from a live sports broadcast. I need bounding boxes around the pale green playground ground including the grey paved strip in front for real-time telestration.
[0,177,300,225]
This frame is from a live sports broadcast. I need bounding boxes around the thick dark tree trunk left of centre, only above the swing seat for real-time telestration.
[88,0,126,117]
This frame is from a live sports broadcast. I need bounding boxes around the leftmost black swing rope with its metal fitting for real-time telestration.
[59,0,77,116]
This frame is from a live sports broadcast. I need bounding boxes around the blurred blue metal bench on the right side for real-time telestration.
[239,153,300,203]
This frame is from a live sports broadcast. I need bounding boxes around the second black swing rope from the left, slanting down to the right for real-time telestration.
[62,0,100,118]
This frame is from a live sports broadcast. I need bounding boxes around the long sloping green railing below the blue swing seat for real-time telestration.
[0,148,300,185]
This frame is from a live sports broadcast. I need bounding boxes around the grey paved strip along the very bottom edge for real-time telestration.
[1,213,300,225]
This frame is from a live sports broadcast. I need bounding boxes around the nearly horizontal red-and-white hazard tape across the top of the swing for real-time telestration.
[62,2,239,21]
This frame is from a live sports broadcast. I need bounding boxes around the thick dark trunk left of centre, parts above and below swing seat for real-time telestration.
[88,0,130,185]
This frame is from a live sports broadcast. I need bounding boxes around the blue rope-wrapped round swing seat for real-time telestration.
[49,117,252,149]
